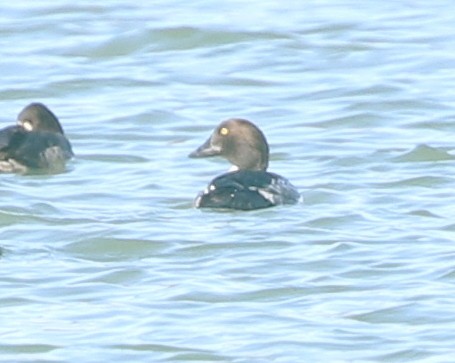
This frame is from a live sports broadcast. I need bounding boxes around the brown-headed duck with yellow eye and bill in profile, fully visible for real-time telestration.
[188,118,301,211]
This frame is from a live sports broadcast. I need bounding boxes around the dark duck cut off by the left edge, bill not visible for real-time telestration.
[0,102,74,173]
